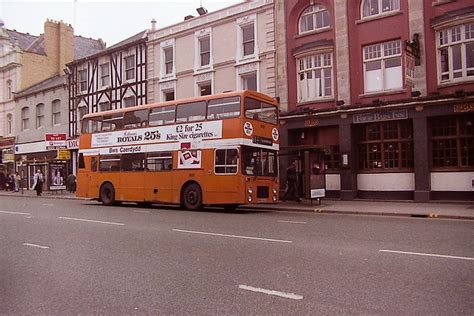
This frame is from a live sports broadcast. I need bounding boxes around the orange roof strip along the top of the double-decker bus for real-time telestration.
[82,90,277,119]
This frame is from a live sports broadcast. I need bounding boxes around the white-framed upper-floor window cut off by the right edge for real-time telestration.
[436,23,474,82]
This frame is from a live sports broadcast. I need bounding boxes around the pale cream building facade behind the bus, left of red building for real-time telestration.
[148,0,277,102]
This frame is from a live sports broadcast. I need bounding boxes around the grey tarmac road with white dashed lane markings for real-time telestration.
[0,197,474,315]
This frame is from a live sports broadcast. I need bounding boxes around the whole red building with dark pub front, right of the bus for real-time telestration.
[281,0,474,201]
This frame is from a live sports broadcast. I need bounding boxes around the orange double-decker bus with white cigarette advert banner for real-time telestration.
[76,91,279,210]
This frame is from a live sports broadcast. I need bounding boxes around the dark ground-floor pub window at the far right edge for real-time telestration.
[430,114,474,168]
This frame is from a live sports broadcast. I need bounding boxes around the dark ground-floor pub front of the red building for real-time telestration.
[281,99,474,202]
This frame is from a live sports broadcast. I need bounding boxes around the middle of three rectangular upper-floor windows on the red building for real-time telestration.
[364,41,403,93]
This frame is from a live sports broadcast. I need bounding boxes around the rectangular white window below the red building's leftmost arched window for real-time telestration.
[297,53,333,102]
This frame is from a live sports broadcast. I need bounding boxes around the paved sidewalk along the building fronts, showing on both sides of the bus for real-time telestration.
[0,190,474,220]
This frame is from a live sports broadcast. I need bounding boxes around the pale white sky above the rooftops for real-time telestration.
[0,0,242,47]
